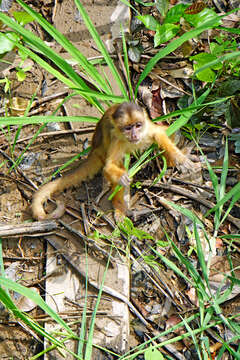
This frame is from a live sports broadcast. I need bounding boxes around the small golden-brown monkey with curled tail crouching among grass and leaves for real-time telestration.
[32,102,199,220]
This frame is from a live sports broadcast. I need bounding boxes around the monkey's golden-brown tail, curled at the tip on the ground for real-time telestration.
[32,152,103,220]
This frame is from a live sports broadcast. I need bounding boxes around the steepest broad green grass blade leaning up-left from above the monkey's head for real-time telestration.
[75,0,128,100]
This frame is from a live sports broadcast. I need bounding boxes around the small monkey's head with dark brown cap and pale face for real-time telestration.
[112,102,146,144]
